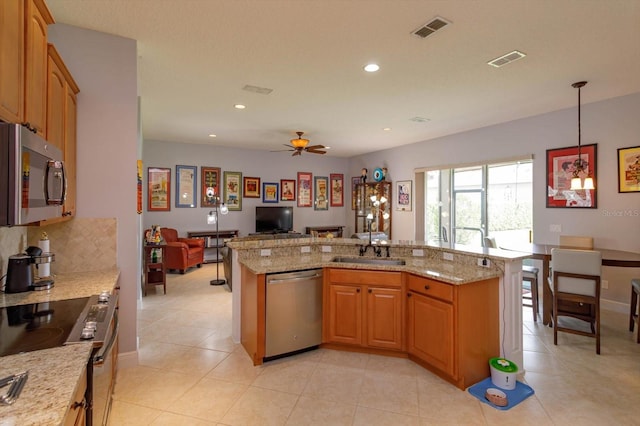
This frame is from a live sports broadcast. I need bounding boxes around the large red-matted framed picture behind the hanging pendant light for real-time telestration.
[547,144,598,209]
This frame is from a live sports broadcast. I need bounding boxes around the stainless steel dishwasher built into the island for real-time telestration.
[265,269,322,361]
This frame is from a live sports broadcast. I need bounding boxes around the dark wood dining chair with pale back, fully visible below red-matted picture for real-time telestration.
[549,248,602,354]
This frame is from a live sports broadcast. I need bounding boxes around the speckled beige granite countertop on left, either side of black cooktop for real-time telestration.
[0,269,120,426]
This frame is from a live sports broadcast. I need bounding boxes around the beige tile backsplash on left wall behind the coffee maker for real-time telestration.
[27,218,118,274]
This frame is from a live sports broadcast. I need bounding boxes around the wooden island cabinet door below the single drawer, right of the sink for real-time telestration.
[408,293,455,377]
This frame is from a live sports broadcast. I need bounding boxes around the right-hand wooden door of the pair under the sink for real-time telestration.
[367,287,403,349]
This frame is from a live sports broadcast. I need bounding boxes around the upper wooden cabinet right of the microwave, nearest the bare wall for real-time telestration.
[46,44,80,217]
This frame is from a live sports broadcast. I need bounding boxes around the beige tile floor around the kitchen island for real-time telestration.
[110,265,640,426]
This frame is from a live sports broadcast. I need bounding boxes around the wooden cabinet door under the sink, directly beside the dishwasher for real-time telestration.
[328,284,363,345]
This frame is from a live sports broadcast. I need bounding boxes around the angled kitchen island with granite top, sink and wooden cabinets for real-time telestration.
[229,238,524,388]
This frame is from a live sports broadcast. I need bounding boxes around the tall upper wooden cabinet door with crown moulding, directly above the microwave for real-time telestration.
[23,0,54,137]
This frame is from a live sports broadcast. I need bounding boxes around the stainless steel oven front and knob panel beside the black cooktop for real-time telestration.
[66,292,118,426]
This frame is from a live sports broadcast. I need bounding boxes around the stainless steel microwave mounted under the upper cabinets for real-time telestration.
[0,123,67,226]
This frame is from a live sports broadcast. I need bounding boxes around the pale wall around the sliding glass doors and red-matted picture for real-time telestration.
[349,92,640,303]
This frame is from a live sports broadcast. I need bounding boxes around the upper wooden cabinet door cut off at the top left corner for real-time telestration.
[0,0,24,123]
